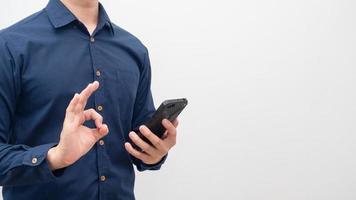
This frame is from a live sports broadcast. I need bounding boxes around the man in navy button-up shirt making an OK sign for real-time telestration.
[0,0,177,200]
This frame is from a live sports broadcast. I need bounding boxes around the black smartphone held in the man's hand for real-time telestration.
[133,98,188,149]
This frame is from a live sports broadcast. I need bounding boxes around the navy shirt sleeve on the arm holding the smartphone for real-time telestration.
[131,49,167,171]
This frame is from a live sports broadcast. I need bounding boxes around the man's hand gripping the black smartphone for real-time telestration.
[125,119,178,165]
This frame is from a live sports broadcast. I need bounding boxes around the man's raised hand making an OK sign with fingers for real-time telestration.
[47,81,109,170]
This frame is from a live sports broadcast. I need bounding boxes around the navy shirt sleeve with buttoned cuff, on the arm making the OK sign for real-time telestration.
[0,37,56,186]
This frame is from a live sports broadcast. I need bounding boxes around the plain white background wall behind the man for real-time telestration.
[0,0,356,200]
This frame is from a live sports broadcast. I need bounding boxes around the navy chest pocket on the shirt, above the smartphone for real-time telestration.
[104,68,140,120]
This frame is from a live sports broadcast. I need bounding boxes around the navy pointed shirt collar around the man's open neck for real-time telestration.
[45,0,114,34]
